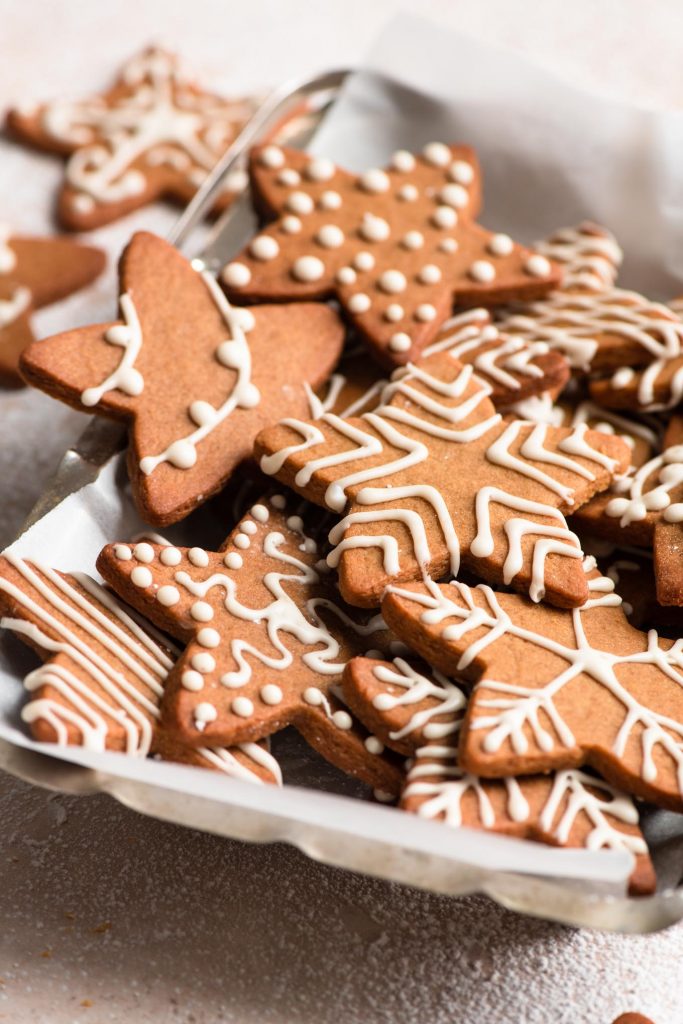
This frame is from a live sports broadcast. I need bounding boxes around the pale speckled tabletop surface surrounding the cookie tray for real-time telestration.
[0,0,683,1024]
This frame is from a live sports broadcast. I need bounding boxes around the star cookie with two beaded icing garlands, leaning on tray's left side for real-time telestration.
[22,231,343,525]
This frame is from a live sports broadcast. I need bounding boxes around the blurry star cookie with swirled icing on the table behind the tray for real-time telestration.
[7,47,255,230]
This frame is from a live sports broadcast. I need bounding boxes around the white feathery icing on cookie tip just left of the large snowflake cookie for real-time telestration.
[373,657,467,739]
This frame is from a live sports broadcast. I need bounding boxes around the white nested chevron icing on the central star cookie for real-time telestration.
[261,362,613,600]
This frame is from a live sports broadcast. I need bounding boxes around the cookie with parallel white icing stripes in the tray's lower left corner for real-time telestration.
[0,552,282,782]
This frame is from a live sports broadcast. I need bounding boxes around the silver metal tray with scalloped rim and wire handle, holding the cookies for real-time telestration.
[0,59,683,932]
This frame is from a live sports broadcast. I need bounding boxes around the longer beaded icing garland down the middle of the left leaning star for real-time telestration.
[140,272,260,476]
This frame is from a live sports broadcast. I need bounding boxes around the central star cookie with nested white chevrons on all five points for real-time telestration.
[255,352,630,607]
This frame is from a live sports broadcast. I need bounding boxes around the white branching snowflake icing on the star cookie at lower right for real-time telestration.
[394,577,683,795]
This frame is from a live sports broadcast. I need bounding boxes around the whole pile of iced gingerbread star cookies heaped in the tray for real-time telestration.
[0,58,683,893]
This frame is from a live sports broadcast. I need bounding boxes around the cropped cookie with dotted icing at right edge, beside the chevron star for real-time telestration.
[577,416,683,605]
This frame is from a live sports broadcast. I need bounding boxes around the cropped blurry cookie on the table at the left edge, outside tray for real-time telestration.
[0,224,105,386]
